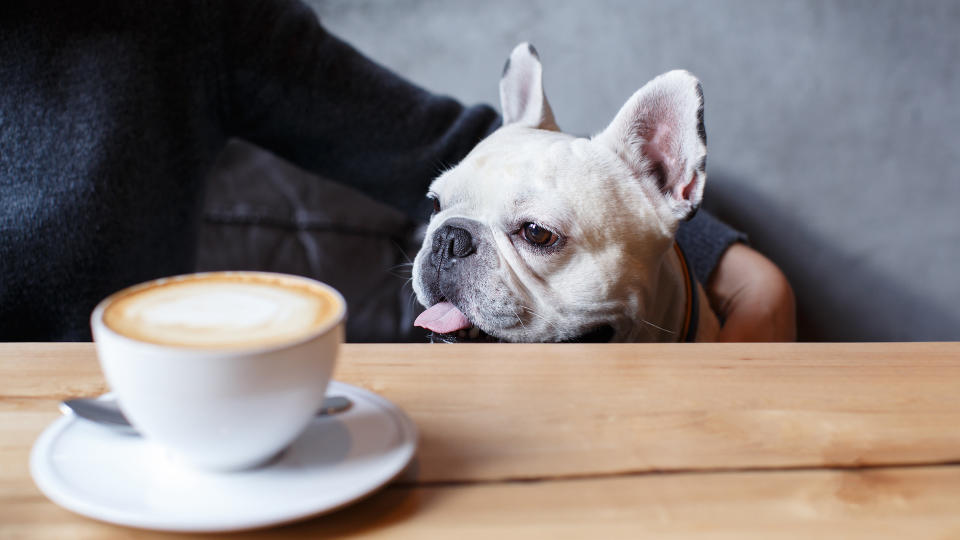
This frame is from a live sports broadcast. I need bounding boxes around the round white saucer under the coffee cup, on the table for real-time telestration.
[30,382,417,532]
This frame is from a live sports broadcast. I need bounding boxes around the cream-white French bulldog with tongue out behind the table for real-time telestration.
[413,43,719,342]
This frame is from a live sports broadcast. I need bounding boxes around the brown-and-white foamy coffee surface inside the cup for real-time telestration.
[103,273,341,348]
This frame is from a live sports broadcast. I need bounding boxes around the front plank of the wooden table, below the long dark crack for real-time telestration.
[0,467,960,540]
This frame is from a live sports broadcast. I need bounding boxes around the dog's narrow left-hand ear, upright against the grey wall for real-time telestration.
[500,43,560,131]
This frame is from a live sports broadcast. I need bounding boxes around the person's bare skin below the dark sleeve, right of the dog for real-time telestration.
[706,243,797,342]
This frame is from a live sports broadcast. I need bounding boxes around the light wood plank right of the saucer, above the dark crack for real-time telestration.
[338,344,960,481]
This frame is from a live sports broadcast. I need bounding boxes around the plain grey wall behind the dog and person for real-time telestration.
[312,0,960,340]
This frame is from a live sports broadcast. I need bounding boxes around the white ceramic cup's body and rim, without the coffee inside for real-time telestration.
[91,272,346,471]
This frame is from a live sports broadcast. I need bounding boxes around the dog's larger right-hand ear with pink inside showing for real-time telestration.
[595,70,707,219]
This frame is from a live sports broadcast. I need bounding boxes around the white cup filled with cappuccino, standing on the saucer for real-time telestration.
[90,272,346,471]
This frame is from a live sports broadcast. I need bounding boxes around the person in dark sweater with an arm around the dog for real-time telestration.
[0,0,792,341]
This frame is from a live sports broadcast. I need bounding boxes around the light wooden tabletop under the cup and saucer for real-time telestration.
[0,343,960,539]
